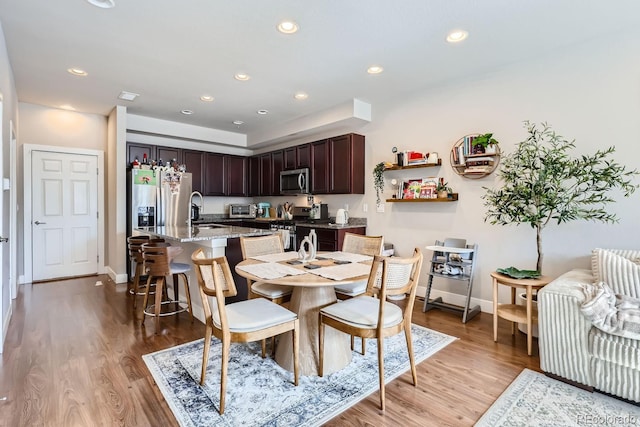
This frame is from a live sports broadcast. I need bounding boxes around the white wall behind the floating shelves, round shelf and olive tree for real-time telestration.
[358,31,640,309]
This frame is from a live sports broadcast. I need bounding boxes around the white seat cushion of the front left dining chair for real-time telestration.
[212,298,297,332]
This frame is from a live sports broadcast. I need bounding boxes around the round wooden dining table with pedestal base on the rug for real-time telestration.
[235,252,371,375]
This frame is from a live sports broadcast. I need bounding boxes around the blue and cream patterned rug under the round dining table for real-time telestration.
[143,325,456,427]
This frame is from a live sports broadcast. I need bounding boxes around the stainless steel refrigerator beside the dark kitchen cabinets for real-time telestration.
[127,169,192,236]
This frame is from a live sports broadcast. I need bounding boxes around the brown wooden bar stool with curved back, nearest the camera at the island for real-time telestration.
[141,242,193,334]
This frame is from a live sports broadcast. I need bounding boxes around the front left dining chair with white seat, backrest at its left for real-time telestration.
[191,249,299,415]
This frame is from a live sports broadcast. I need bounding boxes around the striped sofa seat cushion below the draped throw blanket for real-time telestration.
[589,327,640,370]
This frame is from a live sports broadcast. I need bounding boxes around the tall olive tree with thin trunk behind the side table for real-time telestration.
[482,121,638,272]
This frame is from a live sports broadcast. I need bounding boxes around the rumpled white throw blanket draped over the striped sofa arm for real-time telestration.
[580,282,640,340]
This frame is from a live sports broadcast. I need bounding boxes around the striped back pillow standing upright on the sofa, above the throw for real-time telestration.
[591,248,640,298]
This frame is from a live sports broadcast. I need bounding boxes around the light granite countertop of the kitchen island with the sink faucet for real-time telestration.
[137,224,273,242]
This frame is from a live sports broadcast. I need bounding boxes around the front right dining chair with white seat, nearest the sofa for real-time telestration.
[318,248,422,411]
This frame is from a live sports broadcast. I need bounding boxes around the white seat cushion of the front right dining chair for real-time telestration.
[320,296,402,329]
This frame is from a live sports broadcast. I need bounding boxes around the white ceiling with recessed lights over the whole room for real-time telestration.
[0,0,640,144]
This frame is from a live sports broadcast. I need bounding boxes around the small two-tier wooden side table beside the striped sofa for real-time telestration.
[491,271,551,356]
